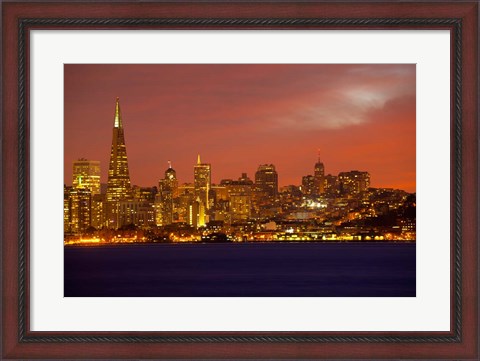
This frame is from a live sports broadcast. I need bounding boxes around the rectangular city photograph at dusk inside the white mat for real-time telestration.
[63,64,416,297]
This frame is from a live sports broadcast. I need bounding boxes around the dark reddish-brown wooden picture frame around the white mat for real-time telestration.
[0,0,479,360]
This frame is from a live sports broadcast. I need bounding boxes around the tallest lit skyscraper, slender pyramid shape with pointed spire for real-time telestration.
[106,98,131,228]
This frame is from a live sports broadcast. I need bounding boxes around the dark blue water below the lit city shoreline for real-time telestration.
[64,243,416,297]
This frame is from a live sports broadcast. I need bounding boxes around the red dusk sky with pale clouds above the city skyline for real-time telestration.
[64,64,416,192]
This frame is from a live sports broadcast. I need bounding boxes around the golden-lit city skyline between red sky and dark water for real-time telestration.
[63,97,416,238]
